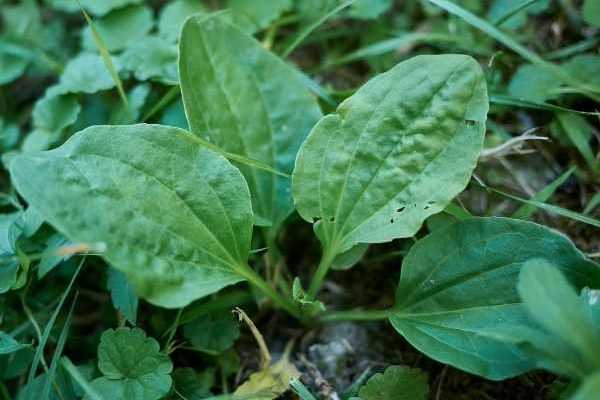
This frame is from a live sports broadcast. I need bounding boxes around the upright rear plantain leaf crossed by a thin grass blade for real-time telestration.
[179,15,321,228]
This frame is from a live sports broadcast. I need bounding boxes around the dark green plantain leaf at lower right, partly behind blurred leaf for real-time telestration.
[390,218,600,379]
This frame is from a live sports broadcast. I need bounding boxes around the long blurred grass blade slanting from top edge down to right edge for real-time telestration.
[429,0,600,101]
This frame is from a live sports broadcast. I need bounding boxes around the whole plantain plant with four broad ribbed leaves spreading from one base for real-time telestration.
[10,14,600,396]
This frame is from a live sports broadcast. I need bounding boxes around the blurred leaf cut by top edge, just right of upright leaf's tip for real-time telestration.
[227,0,292,34]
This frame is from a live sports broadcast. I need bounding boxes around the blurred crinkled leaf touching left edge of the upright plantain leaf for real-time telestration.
[119,36,179,85]
